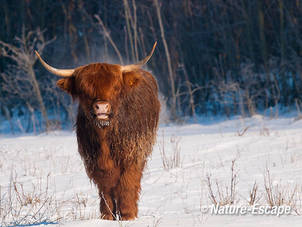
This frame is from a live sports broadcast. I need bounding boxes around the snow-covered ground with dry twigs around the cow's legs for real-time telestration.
[0,115,302,227]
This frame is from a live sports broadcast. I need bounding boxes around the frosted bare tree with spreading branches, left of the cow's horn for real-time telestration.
[0,27,53,130]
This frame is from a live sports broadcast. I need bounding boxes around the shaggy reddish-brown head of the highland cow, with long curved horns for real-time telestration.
[36,42,156,127]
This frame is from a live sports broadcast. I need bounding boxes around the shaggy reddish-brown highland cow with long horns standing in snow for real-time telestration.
[36,43,160,220]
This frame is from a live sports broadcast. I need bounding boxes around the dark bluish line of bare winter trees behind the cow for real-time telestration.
[0,0,302,131]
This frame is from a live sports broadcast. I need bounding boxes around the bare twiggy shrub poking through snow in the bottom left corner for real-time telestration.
[0,175,60,226]
